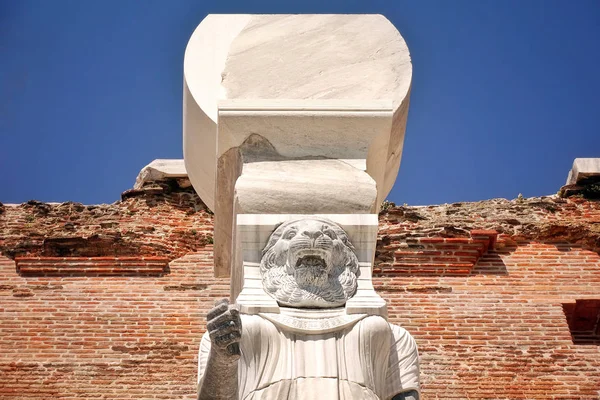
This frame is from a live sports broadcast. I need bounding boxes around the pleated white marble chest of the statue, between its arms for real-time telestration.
[239,317,389,399]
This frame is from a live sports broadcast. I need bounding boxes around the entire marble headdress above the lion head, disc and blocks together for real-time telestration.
[183,15,412,276]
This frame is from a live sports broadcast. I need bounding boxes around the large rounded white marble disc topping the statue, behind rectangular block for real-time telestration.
[184,14,412,208]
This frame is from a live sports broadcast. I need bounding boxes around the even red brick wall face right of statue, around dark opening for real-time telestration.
[375,243,600,399]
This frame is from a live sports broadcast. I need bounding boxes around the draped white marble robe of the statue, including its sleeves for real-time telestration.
[198,315,419,400]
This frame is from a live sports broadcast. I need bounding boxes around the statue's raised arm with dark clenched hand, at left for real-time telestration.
[198,299,242,400]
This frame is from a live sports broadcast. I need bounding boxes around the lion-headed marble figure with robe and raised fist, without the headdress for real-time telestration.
[198,218,419,400]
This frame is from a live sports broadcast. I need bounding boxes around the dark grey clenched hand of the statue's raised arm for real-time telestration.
[206,299,242,363]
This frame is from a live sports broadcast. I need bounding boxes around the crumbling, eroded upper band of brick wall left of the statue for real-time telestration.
[0,183,212,260]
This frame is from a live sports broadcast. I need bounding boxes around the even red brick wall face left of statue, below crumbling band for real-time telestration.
[0,250,229,399]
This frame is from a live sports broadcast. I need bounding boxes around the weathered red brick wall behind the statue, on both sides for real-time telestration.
[0,192,600,399]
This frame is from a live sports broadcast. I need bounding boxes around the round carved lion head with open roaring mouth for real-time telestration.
[260,218,359,308]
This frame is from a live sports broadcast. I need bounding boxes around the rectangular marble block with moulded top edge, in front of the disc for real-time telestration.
[218,99,393,161]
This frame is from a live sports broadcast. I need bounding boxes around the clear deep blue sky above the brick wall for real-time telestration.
[0,0,600,205]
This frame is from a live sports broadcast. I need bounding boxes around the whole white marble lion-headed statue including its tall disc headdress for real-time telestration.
[183,14,420,400]
